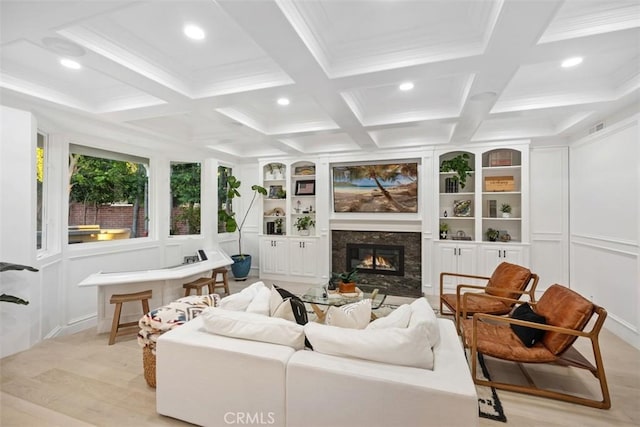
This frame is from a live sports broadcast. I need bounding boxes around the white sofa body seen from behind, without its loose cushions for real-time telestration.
[156,310,479,427]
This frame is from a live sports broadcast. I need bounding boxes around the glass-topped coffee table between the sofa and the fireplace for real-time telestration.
[300,285,387,323]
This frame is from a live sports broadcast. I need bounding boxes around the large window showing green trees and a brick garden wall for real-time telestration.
[69,144,149,244]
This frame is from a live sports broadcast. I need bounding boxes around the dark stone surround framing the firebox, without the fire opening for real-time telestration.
[331,230,422,298]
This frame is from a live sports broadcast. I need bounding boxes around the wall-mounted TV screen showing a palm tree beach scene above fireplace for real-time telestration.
[333,162,418,213]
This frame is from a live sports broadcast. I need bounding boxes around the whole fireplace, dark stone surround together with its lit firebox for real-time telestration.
[331,230,422,298]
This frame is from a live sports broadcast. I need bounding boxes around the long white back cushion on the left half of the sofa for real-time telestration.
[200,307,304,350]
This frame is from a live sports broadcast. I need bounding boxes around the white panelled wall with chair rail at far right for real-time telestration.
[569,116,640,348]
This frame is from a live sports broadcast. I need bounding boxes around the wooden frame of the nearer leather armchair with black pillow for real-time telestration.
[463,295,611,409]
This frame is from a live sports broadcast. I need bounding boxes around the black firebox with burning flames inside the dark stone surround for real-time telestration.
[347,243,404,276]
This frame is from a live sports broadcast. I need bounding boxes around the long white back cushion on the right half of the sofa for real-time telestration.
[304,322,433,369]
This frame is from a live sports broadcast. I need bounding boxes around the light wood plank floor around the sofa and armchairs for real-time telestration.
[0,284,640,427]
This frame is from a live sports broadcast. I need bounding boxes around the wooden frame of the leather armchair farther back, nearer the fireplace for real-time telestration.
[440,272,540,335]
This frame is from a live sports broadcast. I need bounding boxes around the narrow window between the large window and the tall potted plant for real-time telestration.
[170,162,201,236]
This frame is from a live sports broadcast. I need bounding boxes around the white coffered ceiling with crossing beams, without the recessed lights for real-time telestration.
[0,0,640,159]
